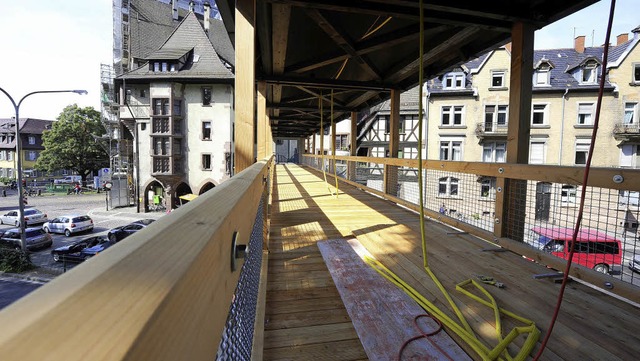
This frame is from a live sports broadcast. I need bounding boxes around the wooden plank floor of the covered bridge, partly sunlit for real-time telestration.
[263,164,640,360]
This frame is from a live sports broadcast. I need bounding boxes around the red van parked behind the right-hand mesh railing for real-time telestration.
[531,227,622,273]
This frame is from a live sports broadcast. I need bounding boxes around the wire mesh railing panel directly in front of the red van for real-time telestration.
[506,181,640,283]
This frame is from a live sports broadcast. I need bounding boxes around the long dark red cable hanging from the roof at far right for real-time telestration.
[534,0,616,360]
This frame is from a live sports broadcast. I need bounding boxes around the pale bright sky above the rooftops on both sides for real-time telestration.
[0,0,640,120]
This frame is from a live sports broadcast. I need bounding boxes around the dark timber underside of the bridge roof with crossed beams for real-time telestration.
[217,0,597,137]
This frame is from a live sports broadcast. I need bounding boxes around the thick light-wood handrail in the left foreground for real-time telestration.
[0,156,271,360]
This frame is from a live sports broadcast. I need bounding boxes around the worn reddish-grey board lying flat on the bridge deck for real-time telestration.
[318,239,471,361]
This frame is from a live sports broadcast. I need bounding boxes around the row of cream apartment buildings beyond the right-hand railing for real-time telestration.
[350,27,640,233]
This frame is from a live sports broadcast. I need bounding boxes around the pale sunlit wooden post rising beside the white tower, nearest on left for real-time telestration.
[234,0,256,174]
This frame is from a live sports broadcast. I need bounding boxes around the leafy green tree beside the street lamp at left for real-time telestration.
[35,104,109,184]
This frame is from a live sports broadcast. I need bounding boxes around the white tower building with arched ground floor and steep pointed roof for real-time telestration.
[116,13,234,210]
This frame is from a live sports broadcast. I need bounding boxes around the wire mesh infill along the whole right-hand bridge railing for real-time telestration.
[304,157,640,286]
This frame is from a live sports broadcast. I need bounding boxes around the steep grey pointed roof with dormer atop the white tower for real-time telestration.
[118,13,233,81]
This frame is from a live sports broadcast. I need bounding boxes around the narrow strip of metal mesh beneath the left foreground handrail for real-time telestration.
[216,200,264,361]
